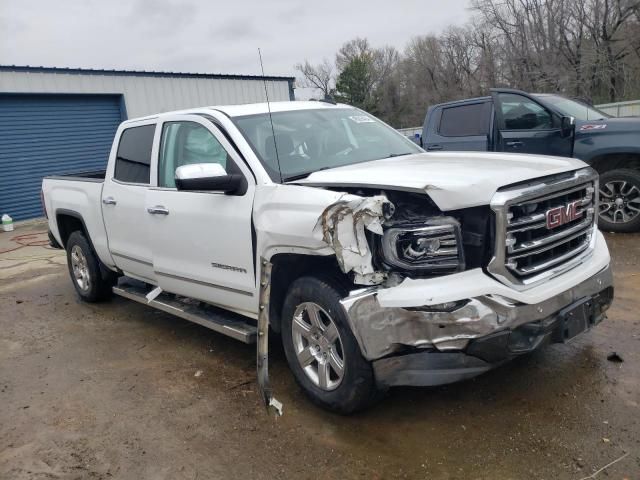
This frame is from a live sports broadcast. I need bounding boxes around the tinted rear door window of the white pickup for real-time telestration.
[114,124,156,184]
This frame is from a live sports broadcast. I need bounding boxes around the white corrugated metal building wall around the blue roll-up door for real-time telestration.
[0,67,290,118]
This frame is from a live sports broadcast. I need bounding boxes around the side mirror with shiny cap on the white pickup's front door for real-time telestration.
[176,163,243,193]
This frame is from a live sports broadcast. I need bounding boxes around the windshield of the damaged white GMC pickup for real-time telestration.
[233,107,422,181]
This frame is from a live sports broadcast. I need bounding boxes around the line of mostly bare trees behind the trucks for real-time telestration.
[295,0,640,128]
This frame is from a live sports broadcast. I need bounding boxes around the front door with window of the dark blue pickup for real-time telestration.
[493,92,573,157]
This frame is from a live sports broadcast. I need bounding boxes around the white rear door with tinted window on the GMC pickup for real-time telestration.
[102,121,156,283]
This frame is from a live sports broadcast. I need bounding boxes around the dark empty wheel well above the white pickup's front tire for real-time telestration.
[269,253,356,332]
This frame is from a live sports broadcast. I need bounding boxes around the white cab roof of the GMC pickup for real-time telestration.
[124,100,354,123]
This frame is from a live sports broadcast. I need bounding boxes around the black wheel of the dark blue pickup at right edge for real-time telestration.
[598,168,640,233]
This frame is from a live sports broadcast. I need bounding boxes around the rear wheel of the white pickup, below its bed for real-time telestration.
[65,231,116,302]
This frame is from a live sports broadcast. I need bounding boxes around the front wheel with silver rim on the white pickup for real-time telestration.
[282,277,380,414]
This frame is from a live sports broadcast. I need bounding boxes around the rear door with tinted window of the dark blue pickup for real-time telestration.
[423,100,492,152]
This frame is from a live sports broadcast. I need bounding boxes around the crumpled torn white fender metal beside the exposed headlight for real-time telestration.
[314,195,393,285]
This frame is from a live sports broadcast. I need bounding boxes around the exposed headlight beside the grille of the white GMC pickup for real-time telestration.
[382,217,464,274]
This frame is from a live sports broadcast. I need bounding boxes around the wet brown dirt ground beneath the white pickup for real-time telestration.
[0,223,640,480]
